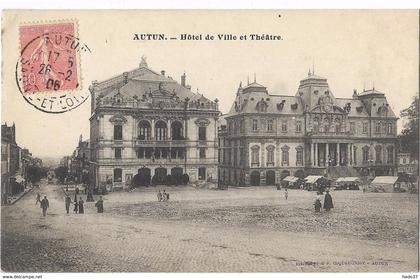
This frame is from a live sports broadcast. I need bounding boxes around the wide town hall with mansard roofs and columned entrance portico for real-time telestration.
[219,72,397,185]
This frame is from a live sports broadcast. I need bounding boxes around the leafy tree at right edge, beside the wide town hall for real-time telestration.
[398,96,420,159]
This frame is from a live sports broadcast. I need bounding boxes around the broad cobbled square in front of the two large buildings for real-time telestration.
[1,182,418,272]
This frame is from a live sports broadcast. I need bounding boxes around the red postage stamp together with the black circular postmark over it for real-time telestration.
[15,22,91,113]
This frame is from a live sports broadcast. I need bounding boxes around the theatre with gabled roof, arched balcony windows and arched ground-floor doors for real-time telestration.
[89,58,219,190]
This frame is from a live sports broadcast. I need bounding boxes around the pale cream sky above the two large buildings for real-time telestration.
[1,10,419,160]
